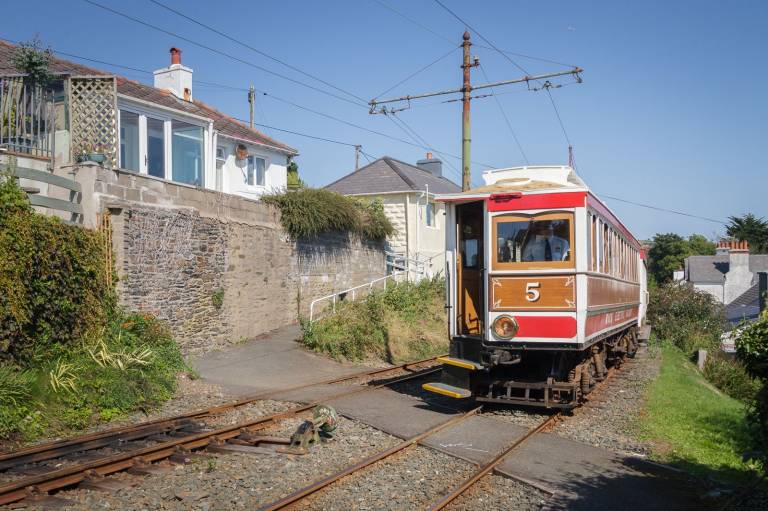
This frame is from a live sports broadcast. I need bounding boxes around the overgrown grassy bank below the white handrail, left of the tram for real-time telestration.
[302,278,448,363]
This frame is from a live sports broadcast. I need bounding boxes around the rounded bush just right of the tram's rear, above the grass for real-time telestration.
[648,282,726,354]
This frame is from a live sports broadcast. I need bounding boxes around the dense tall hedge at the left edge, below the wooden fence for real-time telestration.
[0,176,115,365]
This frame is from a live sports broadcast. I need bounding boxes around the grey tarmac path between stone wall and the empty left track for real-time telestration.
[193,325,366,395]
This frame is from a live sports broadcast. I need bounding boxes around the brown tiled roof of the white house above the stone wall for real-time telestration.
[0,41,298,154]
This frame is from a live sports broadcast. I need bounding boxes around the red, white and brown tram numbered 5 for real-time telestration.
[424,166,647,408]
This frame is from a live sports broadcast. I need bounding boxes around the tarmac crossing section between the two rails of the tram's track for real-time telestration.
[422,416,528,464]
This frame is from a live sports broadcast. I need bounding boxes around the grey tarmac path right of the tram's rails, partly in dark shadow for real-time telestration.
[498,434,707,511]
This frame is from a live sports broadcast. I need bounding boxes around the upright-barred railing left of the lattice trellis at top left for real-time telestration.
[0,77,56,158]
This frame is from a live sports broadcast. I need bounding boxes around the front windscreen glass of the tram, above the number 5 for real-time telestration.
[496,218,571,263]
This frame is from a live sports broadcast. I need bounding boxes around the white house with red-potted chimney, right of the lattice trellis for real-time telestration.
[117,48,298,198]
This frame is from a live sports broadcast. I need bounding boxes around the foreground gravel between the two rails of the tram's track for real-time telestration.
[300,447,474,511]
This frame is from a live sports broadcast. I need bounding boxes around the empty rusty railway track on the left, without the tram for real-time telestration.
[0,357,440,506]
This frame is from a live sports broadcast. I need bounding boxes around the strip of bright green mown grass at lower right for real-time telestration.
[639,344,754,483]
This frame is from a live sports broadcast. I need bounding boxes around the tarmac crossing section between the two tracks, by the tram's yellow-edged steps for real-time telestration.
[330,389,457,439]
